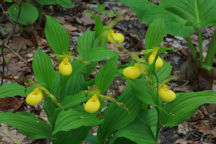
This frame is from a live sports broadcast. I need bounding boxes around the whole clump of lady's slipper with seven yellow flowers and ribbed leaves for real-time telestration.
[0,8,216,144]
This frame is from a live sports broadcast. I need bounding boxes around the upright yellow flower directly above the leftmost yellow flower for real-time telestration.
[59,58,72,76]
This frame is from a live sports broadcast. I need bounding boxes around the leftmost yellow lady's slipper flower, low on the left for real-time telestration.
[26,88,43,106]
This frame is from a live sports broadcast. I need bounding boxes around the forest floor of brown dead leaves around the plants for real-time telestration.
[0,0,216,144]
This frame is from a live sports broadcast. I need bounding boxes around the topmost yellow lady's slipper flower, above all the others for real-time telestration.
[107,30,124,44]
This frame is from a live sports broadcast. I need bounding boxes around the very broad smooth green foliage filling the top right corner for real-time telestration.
[121,0,216,36]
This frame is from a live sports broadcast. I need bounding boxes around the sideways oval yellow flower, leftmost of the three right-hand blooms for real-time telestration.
[122,64,141,79]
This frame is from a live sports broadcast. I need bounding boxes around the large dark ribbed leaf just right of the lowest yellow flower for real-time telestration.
[98,84,141,142]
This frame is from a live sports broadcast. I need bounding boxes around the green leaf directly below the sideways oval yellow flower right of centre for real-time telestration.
[127,78,156,105]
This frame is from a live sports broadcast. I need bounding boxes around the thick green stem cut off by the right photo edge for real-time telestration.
[205,30,216,66]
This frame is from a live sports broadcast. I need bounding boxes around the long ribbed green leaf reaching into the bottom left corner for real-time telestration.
[0,112,51,139]
